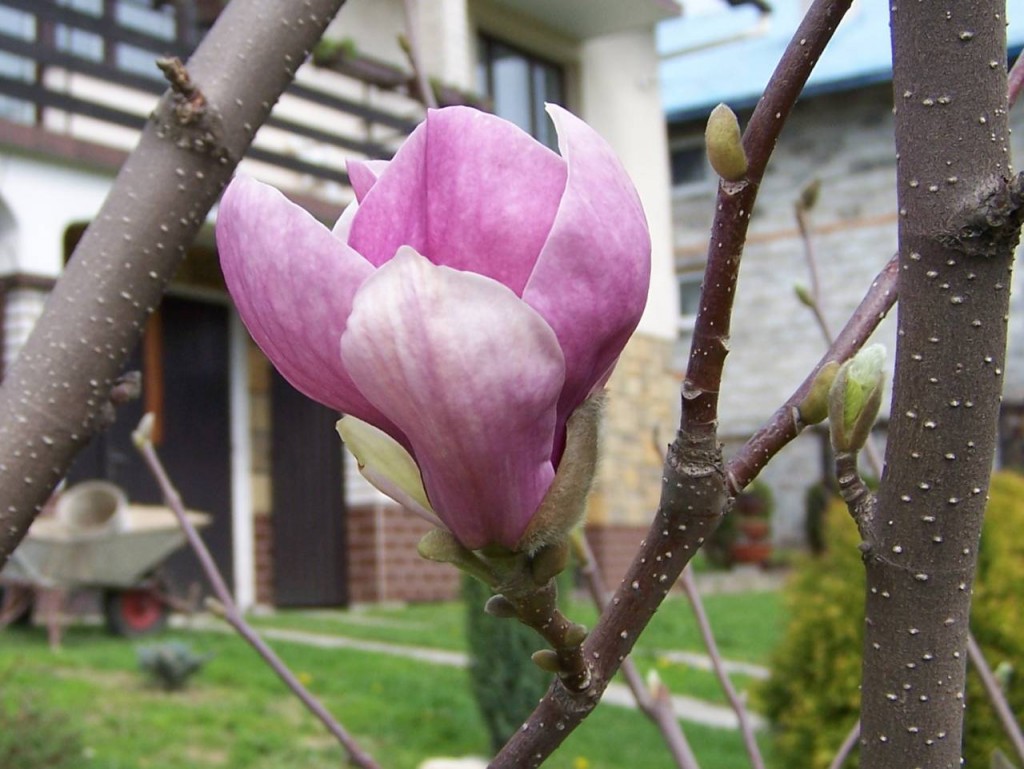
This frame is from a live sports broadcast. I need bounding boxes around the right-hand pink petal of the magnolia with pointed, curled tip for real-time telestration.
[522,104,650,424]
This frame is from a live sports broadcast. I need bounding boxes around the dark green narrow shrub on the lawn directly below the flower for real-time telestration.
[462,576,551,753]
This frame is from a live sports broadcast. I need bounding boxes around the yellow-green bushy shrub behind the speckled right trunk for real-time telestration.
[756,472,1024,769]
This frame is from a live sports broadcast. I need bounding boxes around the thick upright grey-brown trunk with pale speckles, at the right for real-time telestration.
[861,0,1020,769]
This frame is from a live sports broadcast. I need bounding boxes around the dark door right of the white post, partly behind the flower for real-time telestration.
[270,372,348,606]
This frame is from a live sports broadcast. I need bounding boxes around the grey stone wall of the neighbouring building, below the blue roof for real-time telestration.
[670,84,1024,544]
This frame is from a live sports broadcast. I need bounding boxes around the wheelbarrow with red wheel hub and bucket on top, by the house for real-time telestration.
[0,480,210,642]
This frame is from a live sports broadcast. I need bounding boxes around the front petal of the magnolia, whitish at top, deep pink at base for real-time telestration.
[341,248,564,549]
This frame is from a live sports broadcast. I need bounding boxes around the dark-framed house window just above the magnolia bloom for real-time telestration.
[477,37,565,148]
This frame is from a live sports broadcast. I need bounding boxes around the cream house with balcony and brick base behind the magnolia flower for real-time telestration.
[0,0,678,606]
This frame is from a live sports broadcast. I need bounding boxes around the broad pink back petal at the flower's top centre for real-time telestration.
[348,106,566,294]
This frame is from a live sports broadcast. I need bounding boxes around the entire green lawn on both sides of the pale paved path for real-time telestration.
[0,593,782,769]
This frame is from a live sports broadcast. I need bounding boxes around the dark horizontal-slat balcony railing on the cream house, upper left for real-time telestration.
[0,0,422,198]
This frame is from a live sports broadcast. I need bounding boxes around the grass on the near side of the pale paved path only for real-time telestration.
[0,628,774,769]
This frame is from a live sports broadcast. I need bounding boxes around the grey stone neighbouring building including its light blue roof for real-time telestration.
[659,0,1024,546]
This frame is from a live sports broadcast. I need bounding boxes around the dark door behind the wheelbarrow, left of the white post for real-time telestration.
[69,297,232,590]
